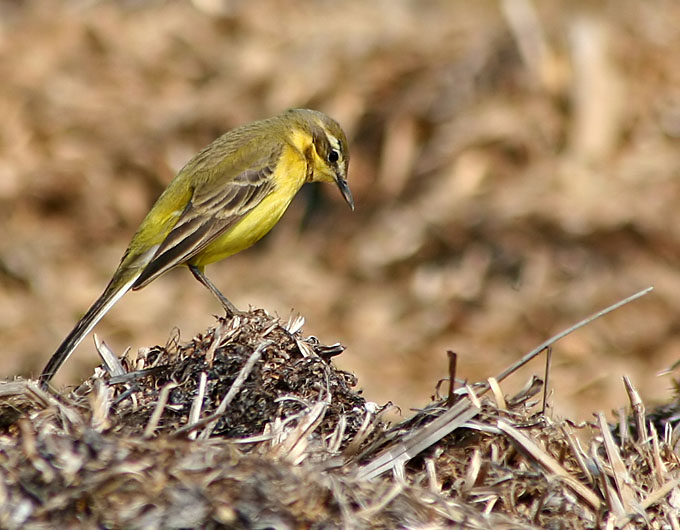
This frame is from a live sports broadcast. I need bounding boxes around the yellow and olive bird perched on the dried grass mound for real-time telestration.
[39,109,354,388]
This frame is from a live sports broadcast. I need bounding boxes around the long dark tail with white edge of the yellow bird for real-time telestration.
[39,274,139,388]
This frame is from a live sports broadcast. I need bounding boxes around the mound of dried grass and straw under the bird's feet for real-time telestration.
[0,304,680,528]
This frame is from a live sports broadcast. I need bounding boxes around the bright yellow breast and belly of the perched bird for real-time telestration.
[190,149,307,267]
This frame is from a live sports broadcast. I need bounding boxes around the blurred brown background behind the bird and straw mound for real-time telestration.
[0,0,680,418]
